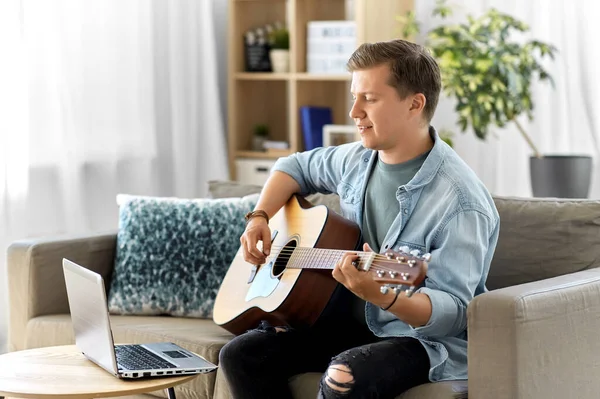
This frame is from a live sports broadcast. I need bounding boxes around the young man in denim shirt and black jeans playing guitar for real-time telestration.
[220,40,499,399]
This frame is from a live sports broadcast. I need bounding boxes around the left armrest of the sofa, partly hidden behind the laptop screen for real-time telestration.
[7,233,116,351]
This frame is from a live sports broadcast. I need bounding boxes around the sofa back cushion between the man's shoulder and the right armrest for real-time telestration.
[486,196,600,289]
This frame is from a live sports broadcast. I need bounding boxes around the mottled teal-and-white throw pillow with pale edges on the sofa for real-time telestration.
[108,194,258,318]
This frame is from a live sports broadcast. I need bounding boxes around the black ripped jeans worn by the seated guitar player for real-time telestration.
[219,322,429,399]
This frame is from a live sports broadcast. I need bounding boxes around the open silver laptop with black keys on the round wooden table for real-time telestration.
[63,259,217,378]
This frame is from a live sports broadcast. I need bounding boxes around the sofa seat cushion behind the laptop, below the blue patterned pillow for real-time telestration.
[27,314,233,399]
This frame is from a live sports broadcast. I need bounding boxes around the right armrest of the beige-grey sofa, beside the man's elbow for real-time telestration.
[468,269,600,399]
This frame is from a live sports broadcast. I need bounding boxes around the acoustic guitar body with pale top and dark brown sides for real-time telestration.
[213,196,360,335]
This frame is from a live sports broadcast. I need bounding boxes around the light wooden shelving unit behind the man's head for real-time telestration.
[228,0,414,179]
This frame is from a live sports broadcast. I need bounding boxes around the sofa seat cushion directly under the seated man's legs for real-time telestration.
[290,373,467,399]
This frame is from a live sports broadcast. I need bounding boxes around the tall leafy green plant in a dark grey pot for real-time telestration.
[397,0,592,197]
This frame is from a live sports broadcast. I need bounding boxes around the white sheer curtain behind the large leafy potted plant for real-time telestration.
[415,0,600,198]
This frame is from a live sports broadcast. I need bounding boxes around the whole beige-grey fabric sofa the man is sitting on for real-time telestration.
[8,182,600,399]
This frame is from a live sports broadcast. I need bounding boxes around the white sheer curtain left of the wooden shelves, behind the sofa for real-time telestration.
[0,0,228,350]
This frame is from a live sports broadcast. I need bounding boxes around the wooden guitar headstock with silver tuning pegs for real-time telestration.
[369,249,431,296]
